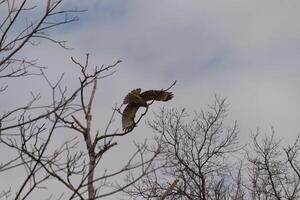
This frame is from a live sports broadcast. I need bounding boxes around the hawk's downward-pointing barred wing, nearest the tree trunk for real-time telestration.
[122,103,140,131]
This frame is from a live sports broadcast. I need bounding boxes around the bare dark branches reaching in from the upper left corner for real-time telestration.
[0,0,83,81]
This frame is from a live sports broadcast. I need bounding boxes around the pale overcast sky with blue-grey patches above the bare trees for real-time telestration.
[4,0,300,198]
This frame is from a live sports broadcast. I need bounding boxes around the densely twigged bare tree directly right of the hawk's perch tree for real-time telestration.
[126,97,242,199]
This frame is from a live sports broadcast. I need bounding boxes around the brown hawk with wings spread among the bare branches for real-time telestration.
[122,88,173,131]
